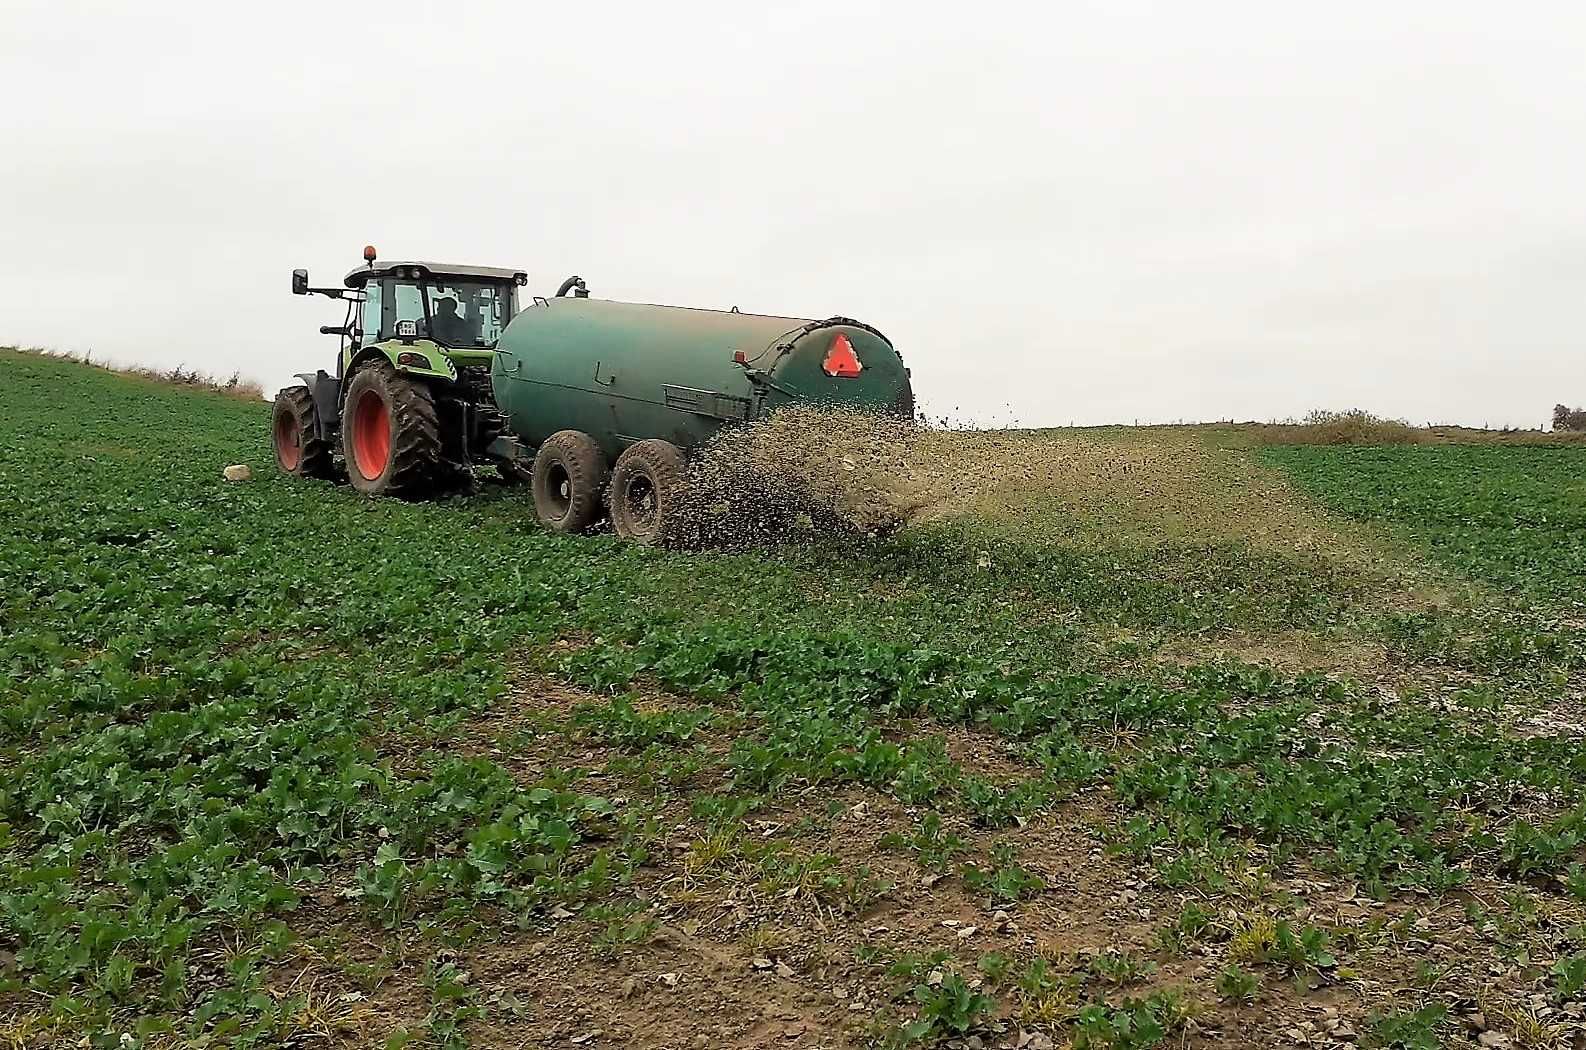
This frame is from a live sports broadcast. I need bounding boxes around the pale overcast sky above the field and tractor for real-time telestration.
[0,0,1586,425]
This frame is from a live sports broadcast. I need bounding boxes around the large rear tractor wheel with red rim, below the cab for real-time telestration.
[341,362,441,500]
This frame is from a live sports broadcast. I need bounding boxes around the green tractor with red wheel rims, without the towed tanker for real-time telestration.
[273,247,545,498]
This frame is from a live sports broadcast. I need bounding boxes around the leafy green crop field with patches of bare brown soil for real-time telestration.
[0,351,1586,1050]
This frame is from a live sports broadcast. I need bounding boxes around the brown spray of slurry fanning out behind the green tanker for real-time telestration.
[668,404,1364,560]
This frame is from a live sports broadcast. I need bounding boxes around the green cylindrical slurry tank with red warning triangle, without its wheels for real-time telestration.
[492,297,914,460]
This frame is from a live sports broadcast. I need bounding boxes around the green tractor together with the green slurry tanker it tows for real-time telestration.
[274,247,914,542]
